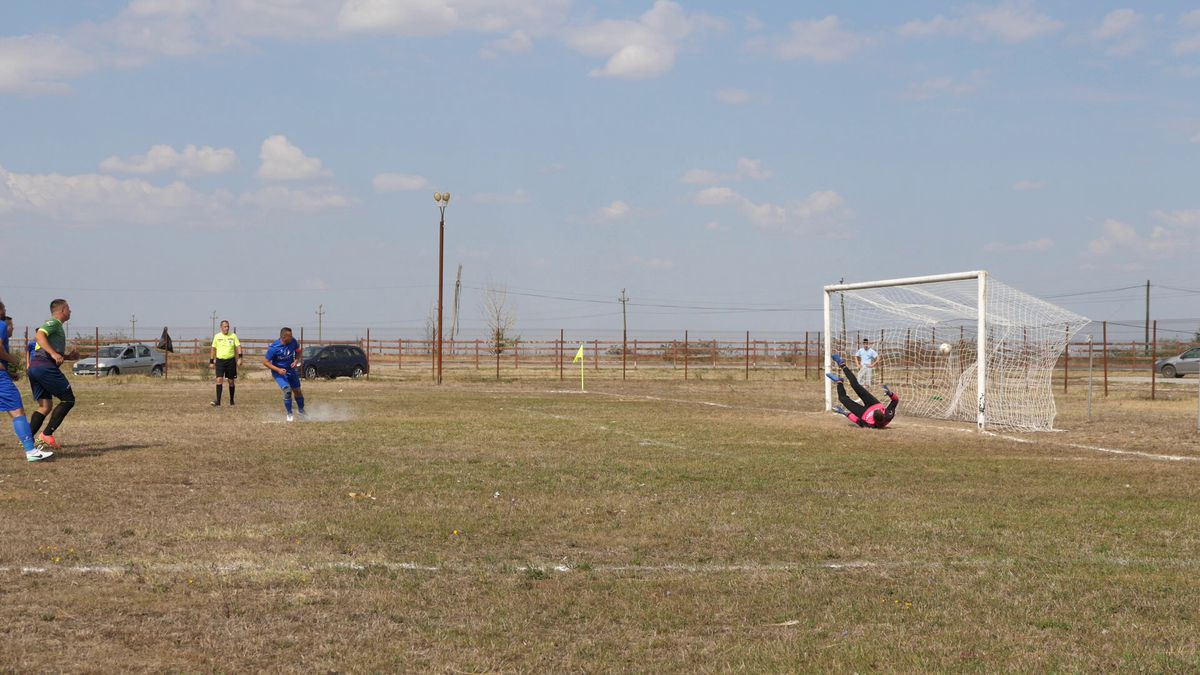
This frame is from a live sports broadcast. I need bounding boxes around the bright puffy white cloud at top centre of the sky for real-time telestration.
[566,0,722,79]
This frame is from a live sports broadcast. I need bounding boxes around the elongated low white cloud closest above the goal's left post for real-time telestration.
[692,187,851,237]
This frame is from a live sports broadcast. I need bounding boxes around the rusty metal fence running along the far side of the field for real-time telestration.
[14,323,1198,399]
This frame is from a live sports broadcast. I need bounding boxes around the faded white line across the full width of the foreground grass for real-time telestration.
[0,556,1200,577]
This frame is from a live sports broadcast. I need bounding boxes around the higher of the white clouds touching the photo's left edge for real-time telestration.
[0,35,96,94]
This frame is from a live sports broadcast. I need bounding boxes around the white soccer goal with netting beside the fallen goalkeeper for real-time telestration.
[824,271,1088,431]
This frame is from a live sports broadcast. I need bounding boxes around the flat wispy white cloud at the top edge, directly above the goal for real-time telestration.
[899,0,1063,43]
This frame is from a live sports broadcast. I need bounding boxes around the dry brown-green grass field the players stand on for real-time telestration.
[0,372,1200,673]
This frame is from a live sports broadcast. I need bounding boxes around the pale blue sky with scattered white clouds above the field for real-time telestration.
[0,0,1200,339]
